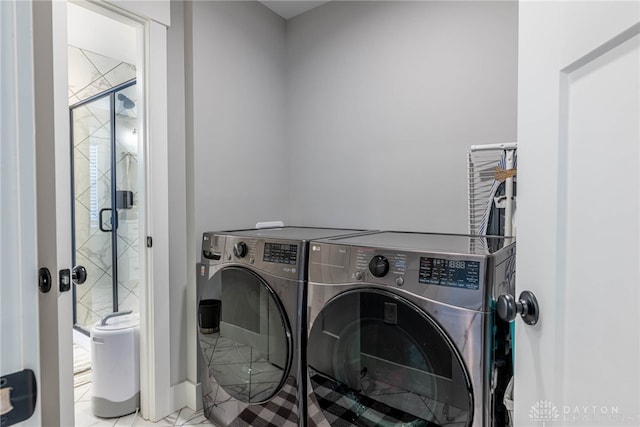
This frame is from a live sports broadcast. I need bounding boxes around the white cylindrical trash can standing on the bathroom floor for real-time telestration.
[91,311,140,418]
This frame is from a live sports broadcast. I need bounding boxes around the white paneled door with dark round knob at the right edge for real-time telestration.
[514,1,640,426]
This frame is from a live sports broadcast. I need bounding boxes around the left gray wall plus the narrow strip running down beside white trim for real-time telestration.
[181,1,289,384]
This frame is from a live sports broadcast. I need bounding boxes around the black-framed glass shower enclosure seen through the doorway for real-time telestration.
[69,80,140,333]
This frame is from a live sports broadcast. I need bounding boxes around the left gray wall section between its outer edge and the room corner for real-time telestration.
[192,1,289,244]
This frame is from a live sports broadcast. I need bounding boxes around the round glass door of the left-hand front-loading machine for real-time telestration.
[199,267,292,403]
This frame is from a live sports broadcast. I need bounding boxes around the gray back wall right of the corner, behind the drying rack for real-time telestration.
[287,1,518,232]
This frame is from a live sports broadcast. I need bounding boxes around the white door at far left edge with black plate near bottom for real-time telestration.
[0,0,42,426]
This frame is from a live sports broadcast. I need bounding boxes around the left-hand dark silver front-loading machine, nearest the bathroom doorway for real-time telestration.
[198,227,370,426]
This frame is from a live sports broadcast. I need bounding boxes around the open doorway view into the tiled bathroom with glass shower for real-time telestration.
[66,3,146,420]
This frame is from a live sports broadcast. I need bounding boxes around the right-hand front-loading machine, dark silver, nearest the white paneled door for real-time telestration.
[307,232,515,427]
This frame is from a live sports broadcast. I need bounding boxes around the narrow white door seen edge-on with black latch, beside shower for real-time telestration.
[32,1,74,426]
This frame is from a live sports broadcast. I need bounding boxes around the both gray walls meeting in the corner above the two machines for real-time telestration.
[178,1,517,394]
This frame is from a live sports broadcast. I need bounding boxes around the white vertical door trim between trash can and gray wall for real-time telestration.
[140,17,172,421]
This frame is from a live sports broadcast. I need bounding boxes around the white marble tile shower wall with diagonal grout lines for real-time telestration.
[68,46,139,329]
